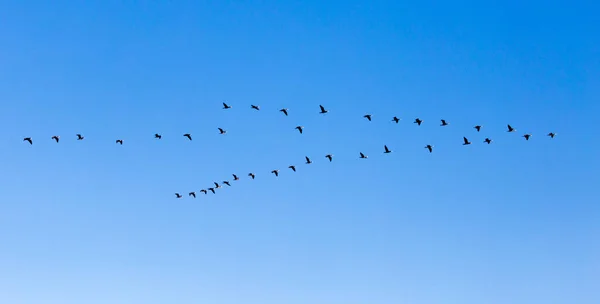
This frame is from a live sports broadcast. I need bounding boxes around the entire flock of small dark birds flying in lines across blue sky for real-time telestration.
[18,102,556,198]
